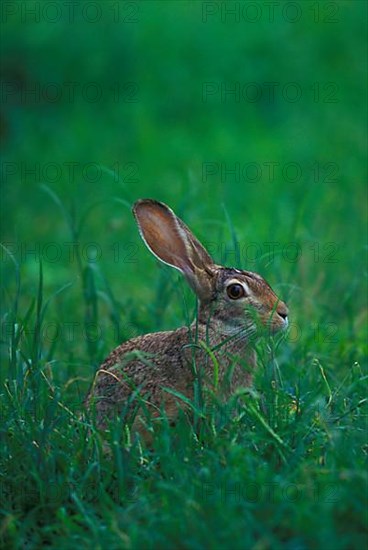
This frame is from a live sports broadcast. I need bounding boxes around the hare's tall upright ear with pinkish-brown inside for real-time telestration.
[133,199,216,300]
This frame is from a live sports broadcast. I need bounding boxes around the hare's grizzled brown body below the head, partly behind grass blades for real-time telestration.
[89,323,255,434]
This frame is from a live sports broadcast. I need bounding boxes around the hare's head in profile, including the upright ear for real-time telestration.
[133,199,288,335]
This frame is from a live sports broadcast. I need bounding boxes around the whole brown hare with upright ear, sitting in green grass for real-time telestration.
[86,199,288,438]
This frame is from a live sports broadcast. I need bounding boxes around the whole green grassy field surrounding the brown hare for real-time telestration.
[0,0,368,550]
